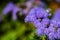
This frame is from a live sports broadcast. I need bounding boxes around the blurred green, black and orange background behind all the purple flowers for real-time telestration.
[0,0,60,40]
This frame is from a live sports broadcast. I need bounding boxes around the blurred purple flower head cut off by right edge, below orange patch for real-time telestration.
[51,8,60,27]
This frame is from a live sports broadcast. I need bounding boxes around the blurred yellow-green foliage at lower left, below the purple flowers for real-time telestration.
[1,21,35,40]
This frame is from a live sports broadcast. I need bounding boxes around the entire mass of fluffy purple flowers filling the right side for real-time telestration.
[25,6,60,40]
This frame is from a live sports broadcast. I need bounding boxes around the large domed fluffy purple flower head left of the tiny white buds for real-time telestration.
[25,6,50,36]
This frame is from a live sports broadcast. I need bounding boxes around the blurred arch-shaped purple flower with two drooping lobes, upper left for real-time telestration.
[3,2,20,20]
